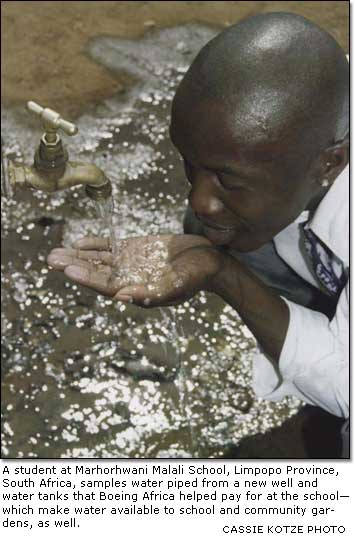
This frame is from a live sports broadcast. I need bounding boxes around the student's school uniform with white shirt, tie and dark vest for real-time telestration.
[184,166,349,457]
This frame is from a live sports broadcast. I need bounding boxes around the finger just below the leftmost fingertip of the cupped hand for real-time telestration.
[64,265,120,296]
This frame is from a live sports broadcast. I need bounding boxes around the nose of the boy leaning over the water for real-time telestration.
[189,168,224,217]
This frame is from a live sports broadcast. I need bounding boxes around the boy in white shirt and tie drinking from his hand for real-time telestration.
[48,13,349,456]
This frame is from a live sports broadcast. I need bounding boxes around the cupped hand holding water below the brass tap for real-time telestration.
[47,235,221,307]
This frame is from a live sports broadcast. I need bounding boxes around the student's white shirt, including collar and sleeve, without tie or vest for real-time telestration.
[253,166,349,418]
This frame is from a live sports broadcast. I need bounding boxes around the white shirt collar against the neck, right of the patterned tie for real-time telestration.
[301,165,349,266]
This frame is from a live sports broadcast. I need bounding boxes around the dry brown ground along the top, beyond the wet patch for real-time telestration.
[1,1,349,118]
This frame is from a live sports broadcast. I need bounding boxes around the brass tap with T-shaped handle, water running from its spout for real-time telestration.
[8,101,112,200]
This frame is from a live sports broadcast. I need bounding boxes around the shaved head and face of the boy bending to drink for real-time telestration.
[170,13,349,251]
